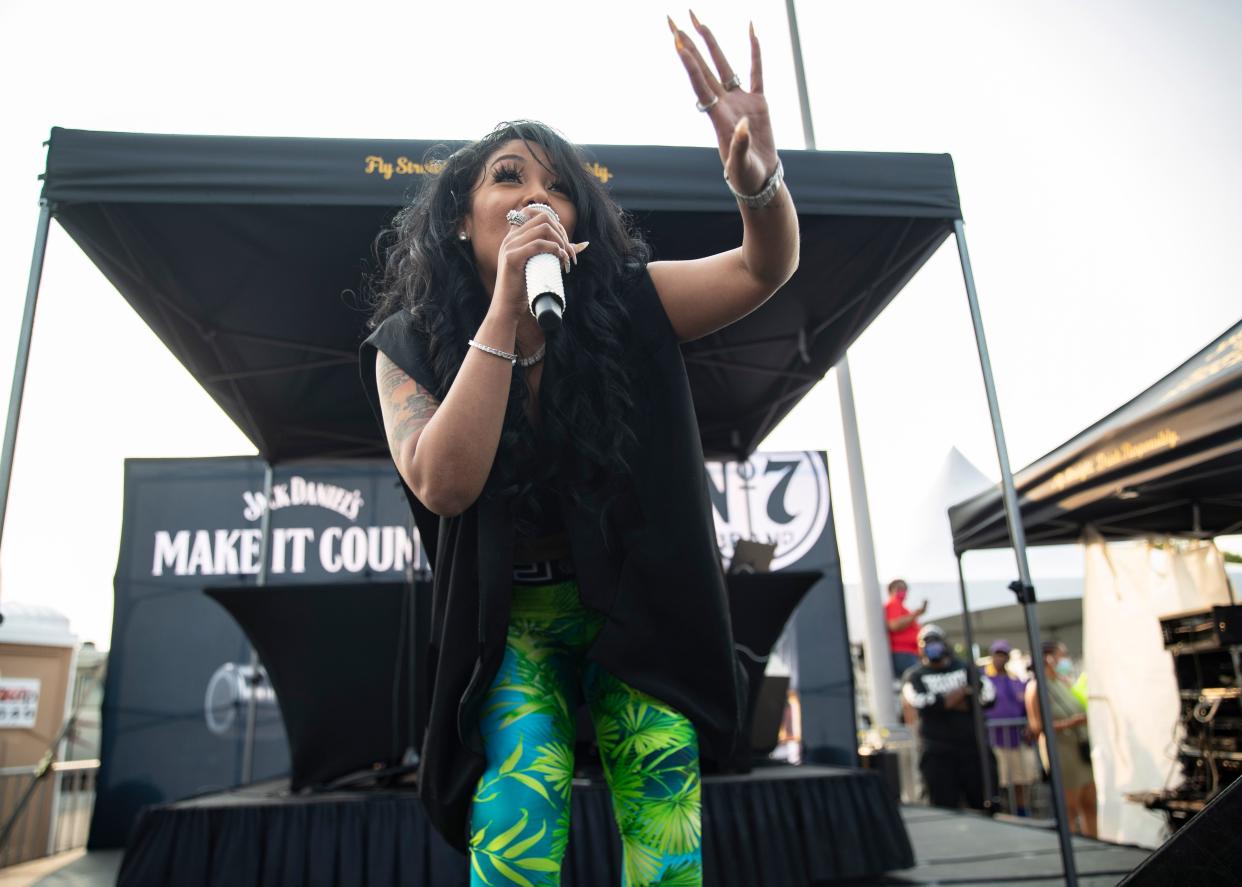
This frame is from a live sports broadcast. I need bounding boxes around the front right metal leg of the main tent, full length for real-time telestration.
[953,219,1078,887]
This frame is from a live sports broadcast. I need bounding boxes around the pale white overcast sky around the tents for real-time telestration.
[0,0,1242,646]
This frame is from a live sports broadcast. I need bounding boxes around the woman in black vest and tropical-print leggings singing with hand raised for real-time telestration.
[361,20,799,887]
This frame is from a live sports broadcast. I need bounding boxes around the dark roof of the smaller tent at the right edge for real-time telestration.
[949,321,1242,553]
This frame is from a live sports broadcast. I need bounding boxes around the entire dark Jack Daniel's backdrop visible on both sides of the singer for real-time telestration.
[89,452,856,848]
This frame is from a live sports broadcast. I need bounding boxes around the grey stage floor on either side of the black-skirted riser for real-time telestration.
[14,806,1150,887]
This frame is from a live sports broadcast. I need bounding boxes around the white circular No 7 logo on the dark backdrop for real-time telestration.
[707,452,831,570]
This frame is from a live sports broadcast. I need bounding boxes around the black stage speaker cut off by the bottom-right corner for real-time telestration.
[1119,779,1242,887]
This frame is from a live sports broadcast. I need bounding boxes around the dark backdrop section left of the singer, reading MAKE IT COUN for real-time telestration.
[89,457,417,847]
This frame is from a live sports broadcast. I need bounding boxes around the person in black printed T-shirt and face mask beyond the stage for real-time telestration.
[902,625,996,810]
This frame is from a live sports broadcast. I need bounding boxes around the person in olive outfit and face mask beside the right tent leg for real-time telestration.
[1026,641,1097,837]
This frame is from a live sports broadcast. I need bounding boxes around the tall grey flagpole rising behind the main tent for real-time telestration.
[785,0,898,728]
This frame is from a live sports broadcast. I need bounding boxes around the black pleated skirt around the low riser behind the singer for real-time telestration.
[117,766,914,887]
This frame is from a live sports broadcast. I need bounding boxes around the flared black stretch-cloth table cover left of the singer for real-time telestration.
[206,583,431,791]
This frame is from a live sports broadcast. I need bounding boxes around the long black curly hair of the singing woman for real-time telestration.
[369,121,650,532]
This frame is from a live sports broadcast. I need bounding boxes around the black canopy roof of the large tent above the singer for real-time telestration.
[43,128,961,462]
